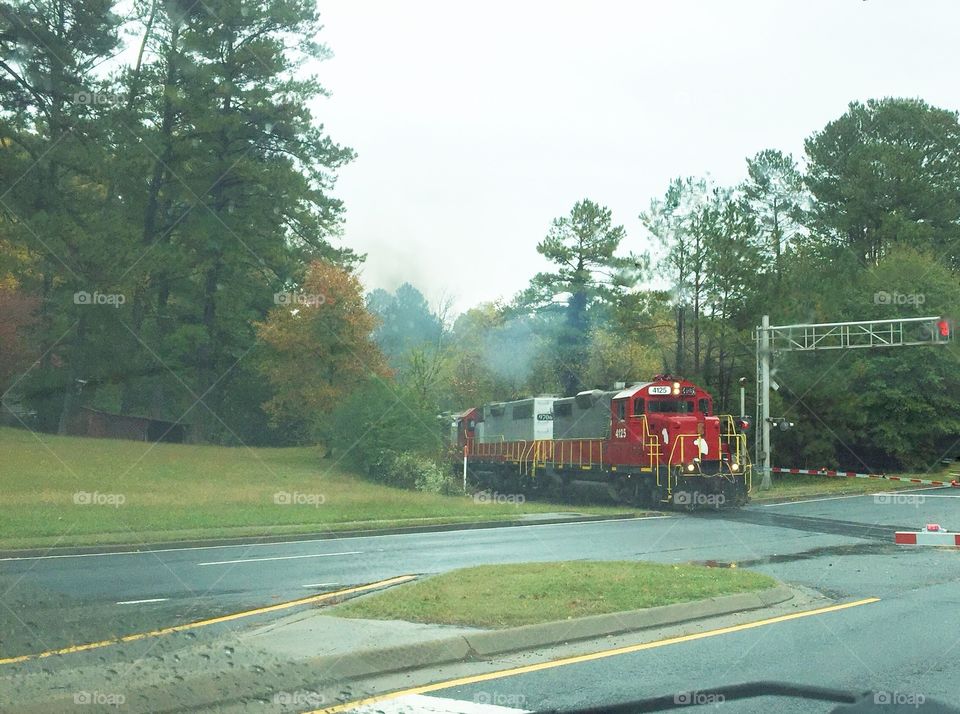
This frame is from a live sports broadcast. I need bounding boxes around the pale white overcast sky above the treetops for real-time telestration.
[317,0,960,310]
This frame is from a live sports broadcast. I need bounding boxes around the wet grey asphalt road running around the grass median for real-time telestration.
[0,489,960,711]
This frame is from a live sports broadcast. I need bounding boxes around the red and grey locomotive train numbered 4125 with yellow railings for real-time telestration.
[449,374,752,510]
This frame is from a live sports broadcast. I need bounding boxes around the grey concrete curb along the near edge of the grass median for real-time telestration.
[311,585,797,680]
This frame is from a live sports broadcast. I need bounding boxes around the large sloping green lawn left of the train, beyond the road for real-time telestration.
[0,428,638,549]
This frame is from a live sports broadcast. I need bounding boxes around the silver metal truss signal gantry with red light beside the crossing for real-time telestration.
[754,315,953,489]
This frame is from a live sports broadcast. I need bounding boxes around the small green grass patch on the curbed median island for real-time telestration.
[330,561,777,628]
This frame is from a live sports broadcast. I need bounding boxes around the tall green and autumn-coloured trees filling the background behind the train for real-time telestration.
[0,5,960,469]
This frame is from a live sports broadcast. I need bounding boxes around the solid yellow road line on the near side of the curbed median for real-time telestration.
[310,597,880,714]
